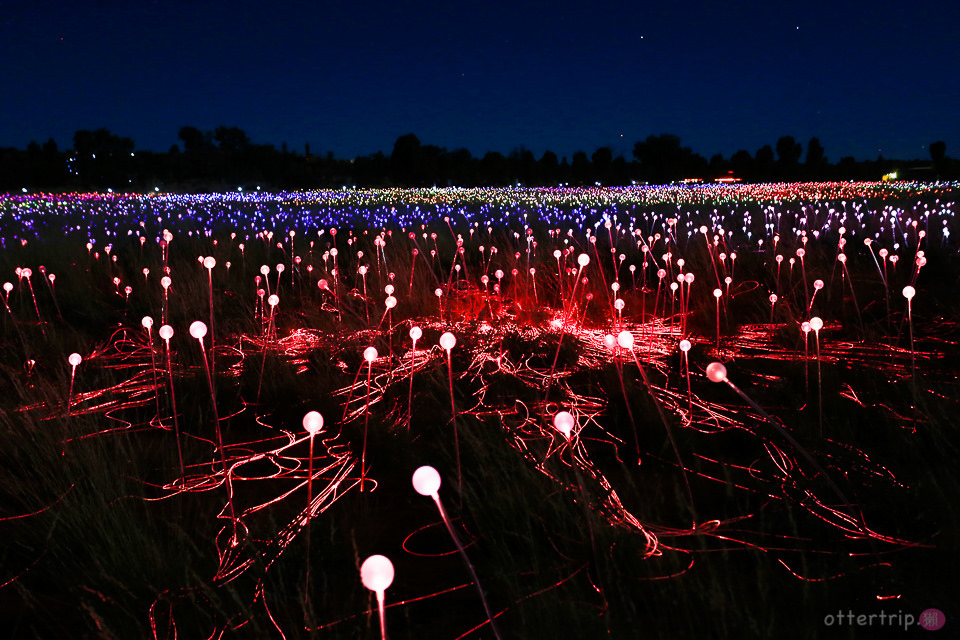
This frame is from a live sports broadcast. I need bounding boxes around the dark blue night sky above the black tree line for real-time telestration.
[0,0,960,162]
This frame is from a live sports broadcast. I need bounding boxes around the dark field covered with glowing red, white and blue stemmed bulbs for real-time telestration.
[0,183,960,639]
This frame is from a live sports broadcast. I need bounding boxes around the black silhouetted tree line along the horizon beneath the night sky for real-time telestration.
[0,126,960,191]
